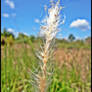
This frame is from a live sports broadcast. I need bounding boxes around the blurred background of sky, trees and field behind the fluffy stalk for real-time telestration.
[1,0,91,92]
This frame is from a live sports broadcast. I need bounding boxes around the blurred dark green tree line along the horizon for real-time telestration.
[1,28,91,45]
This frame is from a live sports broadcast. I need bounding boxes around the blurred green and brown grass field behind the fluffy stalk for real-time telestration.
[1,41,91,92]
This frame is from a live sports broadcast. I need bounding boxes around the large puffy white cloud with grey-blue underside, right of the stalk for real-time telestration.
[70,19,90,30]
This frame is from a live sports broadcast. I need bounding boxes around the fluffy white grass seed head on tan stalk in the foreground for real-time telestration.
[30,0,62,92]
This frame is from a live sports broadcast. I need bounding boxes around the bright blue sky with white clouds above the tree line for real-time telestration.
[1,0,91,39]
